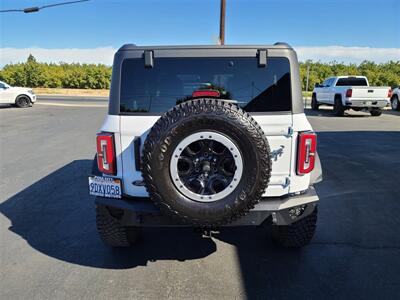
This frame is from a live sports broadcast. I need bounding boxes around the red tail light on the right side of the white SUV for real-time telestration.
[297,132,317,175]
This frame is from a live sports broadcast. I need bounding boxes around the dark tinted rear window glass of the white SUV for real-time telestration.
[120,57,291,113]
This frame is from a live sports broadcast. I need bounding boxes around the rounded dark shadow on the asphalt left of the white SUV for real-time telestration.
[0,160,216,269]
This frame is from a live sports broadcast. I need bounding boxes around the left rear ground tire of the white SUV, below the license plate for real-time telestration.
[96,205,139,247]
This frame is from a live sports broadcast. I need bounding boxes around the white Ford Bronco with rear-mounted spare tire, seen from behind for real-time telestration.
[89,43,322,247]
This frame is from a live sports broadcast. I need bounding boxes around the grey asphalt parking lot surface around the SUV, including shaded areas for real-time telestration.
[0,100,400,299]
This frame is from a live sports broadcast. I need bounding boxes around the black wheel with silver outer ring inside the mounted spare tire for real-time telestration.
[170,131,243,202]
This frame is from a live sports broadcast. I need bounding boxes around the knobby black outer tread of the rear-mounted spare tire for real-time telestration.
[141,98,272,227]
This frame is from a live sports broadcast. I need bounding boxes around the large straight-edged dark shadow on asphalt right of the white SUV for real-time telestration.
[217,130,400,299]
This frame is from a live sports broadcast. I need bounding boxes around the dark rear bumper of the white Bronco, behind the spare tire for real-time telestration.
[95,186,319,227]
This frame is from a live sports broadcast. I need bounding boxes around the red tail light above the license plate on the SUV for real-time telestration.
[96,132,117,175]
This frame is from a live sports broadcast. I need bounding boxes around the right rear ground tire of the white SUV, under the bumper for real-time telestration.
[272,206,318,248]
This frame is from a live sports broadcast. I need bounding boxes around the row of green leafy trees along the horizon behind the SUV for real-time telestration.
[0,55,400,91]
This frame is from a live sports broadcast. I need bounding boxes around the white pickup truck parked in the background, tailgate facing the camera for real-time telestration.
[311,76,392,116]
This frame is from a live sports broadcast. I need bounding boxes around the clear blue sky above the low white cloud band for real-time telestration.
[0,0,400,63]
